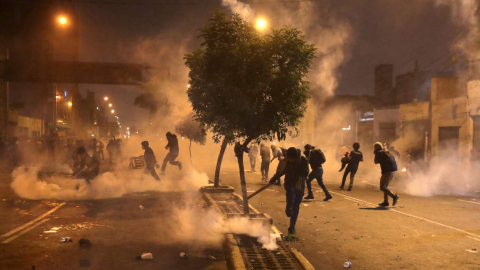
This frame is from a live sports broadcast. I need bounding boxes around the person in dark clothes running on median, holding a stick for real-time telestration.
[269,147,308,235]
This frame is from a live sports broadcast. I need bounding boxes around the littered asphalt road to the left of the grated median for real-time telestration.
[0,165,226,270]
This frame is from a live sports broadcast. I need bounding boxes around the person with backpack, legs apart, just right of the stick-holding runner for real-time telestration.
[304,144,333,201]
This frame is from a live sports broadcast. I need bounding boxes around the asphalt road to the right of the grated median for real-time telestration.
[212,162,480,269]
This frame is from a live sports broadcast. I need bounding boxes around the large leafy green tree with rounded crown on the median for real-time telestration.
[185,13,315,213]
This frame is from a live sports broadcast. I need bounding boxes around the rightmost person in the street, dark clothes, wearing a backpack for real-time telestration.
[373,142,399,206]
